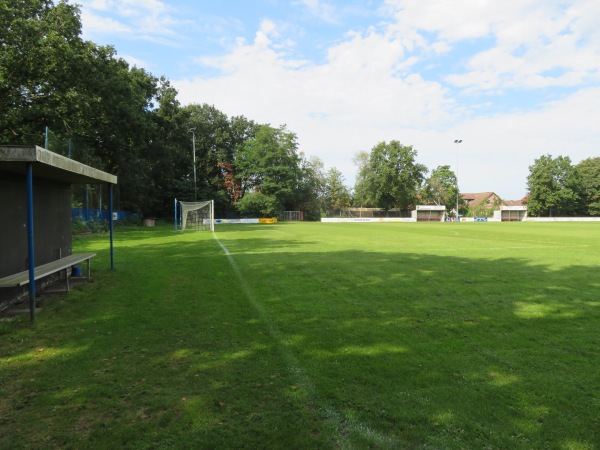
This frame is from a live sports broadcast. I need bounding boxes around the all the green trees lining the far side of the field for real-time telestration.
[0,0,600,219]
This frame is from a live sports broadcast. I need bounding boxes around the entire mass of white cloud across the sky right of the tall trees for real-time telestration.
[174,1,600,198]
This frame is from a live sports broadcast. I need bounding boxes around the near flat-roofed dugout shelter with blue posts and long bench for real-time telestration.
[0,146,117,321]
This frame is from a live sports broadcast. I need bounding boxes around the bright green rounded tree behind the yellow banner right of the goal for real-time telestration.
[235,125,300,216]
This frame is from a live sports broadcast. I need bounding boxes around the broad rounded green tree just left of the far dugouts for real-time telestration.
[355,141,427,210]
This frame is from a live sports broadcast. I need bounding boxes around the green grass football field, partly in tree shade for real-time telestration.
[0,223,600,449]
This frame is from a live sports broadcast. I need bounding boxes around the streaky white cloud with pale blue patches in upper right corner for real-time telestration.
[386,0,600,91]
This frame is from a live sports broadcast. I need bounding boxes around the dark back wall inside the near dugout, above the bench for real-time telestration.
[0,171,72,277]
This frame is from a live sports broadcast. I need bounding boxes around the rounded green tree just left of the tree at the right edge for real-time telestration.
[527,155,584,216]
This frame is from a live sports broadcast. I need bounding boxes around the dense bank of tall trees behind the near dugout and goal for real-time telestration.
[0,0,380,218]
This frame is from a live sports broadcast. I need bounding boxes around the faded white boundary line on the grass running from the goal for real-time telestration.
[214,233,399,448]
